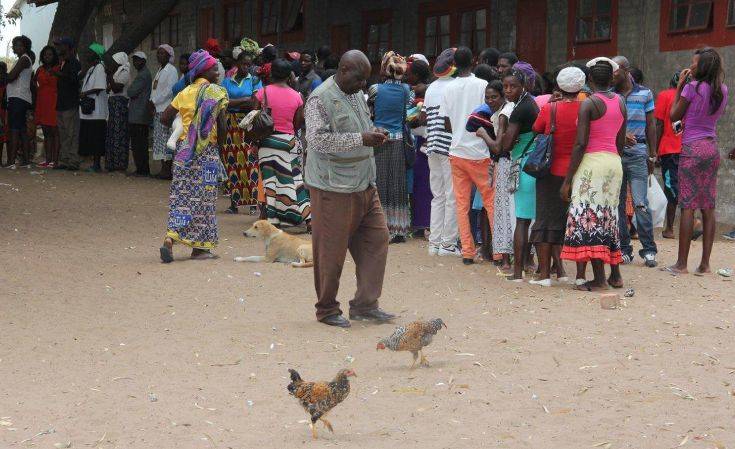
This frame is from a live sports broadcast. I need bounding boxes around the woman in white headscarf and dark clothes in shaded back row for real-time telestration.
[105,52,130,171]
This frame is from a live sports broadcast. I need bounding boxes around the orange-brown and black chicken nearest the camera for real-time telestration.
[286,369,357,439]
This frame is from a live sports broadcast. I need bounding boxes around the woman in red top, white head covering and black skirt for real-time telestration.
[530,67,585,287]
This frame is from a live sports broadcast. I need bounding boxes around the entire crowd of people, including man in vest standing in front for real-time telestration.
[0,36,735,326]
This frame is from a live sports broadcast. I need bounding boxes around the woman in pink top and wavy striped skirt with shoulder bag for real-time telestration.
[255,59,311,226]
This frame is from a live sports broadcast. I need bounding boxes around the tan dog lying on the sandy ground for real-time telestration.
[235,220,314,268]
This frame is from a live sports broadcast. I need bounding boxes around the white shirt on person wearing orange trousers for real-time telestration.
[440,75,490,160]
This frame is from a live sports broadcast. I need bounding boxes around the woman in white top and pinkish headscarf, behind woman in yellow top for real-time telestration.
[151,44,178,179]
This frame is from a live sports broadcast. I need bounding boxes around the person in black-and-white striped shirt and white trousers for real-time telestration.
[424,48,462,257]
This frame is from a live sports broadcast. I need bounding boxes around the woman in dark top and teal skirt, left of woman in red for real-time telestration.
[501,68,538,282]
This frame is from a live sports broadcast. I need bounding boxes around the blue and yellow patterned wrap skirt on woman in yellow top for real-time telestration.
[166,140,221,250]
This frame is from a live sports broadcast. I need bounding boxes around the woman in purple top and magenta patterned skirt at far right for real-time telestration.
[666,48,728,275]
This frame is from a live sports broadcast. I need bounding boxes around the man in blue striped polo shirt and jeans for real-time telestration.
[613,56,658,268]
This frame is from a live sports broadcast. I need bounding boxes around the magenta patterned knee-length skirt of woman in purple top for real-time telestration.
[679,139,720,209]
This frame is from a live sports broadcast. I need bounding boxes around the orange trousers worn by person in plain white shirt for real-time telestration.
[449,156,495,259]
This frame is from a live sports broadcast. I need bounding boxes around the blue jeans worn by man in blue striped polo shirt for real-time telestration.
[618,152,658,257]
